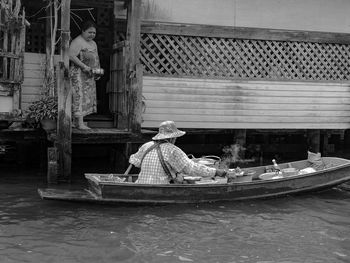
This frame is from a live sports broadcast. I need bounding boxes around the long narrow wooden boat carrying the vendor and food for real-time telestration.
[38,157,350,203]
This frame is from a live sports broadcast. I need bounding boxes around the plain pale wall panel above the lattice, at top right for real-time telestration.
[142,0,350,33]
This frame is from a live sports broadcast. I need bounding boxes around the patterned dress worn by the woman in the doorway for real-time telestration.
[69,36,100,117]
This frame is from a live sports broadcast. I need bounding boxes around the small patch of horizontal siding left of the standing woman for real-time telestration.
[21,52,45,110]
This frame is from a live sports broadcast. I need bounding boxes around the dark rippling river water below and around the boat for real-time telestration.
[0,171,350,263]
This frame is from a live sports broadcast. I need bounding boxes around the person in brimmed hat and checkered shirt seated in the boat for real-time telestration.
[129,121,227,184]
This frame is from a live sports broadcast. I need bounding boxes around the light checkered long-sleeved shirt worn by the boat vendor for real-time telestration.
[129,141,216,184]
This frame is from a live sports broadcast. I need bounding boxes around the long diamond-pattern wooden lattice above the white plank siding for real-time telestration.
[141,33,350,81]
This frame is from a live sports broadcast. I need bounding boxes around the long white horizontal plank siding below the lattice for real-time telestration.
[142,76,350,129]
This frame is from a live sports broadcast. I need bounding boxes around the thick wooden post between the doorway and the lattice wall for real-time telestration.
[125,0,142,132]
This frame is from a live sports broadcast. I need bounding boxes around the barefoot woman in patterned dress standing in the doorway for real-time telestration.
[69,21,100,129]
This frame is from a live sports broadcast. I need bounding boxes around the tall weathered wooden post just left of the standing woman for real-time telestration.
[57,0,72,181]
